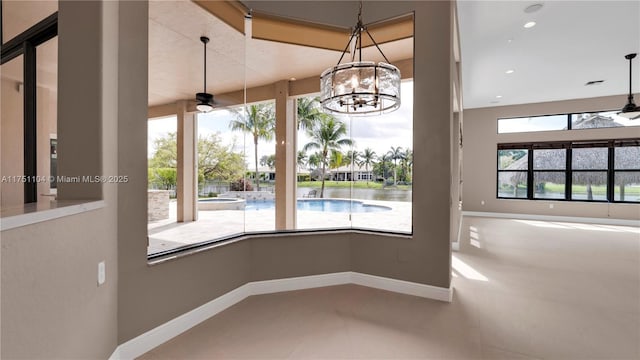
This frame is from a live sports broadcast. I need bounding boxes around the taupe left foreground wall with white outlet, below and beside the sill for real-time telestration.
[0,1,118,359]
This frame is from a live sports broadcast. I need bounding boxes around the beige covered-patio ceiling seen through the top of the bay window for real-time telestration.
[149,0,413,106]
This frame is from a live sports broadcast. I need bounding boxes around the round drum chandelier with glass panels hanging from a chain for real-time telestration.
[320,1,400,115]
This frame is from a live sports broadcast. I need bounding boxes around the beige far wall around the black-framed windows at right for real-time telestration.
[463,94,640,220]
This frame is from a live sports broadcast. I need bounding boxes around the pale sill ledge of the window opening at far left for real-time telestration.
[0,200,105,231]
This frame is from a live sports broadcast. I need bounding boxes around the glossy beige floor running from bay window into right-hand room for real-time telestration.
[142,218,640,359]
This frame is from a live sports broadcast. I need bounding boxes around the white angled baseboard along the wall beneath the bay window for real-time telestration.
[109,271,453,360]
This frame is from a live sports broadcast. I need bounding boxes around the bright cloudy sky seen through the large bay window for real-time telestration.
[147,81,413,166]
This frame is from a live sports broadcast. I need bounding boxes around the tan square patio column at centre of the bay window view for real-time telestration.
[276,80,297,230]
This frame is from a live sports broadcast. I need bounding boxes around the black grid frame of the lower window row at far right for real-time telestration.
[496,138,640,204]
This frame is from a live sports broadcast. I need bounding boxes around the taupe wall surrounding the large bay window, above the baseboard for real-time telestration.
[118,1,452,343]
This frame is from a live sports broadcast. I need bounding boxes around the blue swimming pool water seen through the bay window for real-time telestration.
[245,199,391,213]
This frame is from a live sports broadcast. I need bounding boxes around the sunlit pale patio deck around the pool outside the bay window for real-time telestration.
[148,200,411,254]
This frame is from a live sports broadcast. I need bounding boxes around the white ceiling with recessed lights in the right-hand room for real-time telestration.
[458,0,640,108]
